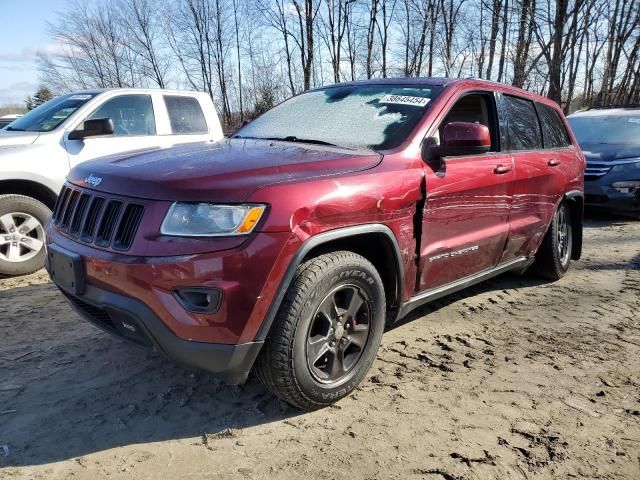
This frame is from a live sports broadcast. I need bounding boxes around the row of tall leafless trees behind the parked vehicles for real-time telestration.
[38,0,640,116]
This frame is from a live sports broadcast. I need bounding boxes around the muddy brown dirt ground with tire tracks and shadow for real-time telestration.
[0,220,640,480]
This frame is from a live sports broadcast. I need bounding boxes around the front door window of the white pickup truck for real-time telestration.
[89,95,156,137]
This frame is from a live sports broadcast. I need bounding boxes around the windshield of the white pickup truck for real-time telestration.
[7,93,95,132]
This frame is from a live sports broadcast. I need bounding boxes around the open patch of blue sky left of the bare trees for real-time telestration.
[0,0,70,106]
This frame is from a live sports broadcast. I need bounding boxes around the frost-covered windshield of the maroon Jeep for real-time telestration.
[234,85,441,149]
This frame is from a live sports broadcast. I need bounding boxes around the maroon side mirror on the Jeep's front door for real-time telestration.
[425,122,491,158]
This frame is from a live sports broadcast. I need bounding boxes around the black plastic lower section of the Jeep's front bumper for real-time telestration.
[53,278,263,384]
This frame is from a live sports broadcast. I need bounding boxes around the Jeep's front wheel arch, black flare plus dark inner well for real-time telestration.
[255,224,404,341]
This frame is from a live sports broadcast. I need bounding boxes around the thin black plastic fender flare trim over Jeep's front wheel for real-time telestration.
[255,223,404,342]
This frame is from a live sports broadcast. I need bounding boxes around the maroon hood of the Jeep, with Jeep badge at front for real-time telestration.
[68,139,382,202]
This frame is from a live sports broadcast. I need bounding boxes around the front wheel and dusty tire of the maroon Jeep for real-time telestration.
[256,251,386,410]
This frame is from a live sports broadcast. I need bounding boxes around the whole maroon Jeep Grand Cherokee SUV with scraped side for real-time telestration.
[47,78,584,409]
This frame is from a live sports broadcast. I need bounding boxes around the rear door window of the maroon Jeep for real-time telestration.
[503,95,543,150]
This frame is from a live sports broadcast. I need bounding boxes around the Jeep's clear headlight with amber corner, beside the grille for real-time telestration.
[160,202,266,237]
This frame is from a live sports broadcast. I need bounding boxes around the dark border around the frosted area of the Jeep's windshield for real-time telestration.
[229,79,445,152]
